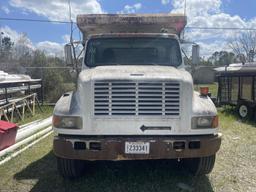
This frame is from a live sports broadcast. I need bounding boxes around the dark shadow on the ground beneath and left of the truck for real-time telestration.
[14,152,213,192]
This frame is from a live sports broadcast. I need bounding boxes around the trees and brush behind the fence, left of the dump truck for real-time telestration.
[0,34,75,103]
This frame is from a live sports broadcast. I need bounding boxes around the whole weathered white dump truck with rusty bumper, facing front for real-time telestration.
[53,14,221,177]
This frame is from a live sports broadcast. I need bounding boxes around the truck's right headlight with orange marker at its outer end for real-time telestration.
[191,116,219,129]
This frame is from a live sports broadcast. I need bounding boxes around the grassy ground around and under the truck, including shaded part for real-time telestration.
[0,108,256,192]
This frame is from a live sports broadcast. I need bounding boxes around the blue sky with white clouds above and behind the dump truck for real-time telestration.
[0,0,256,56]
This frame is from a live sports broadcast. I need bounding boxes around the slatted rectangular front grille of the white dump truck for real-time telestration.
[94,81,180,116]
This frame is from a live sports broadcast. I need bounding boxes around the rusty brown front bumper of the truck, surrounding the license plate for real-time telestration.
[53,133,221,160]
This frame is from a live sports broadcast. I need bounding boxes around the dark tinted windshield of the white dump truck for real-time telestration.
[85,37,181,67]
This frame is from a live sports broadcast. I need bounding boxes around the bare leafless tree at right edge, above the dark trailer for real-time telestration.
[228,31,256,62]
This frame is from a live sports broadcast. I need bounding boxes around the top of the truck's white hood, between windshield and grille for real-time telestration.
[79,65,192,82]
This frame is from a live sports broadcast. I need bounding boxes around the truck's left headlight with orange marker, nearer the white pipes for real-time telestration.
[52,115,83,129]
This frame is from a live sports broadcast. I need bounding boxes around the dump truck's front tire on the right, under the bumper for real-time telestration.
[184,154,215,175]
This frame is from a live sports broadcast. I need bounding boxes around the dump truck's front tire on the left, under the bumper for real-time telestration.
[57,157,85,178]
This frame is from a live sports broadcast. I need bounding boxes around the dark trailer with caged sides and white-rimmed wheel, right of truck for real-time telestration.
[216,63,256,119]
